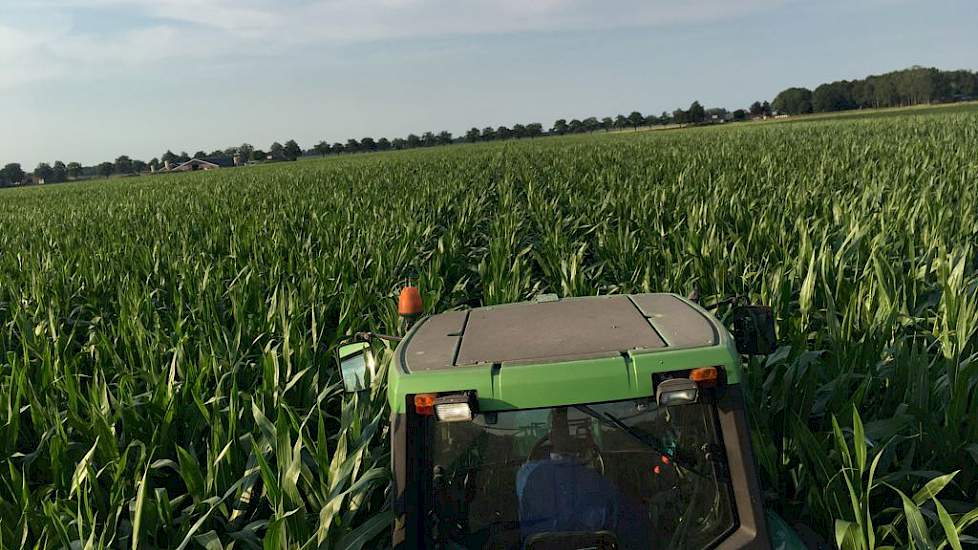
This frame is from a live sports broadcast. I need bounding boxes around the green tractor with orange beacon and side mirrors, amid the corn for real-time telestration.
[339,287,805,550]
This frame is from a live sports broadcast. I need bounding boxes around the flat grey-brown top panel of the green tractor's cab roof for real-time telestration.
[398,294,723,374]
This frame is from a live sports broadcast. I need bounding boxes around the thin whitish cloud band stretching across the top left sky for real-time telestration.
[0,0,784,87]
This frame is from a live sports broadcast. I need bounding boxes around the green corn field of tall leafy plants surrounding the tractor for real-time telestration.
[0,106,978,550]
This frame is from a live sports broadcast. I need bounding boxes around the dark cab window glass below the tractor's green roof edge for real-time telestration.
[425,399,737,550]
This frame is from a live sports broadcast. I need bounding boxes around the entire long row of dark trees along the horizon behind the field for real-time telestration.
[0,66,978,186]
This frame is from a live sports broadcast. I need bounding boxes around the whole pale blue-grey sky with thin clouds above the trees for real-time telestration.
[0,0,978,169]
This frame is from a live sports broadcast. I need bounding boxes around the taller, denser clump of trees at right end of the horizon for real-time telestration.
[772,67,978,115]
